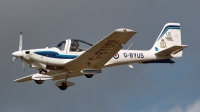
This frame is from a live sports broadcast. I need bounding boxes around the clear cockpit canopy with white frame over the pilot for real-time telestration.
[52,39,93,52]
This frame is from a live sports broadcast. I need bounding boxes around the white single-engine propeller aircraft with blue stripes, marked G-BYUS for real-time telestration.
[12,23,188,90]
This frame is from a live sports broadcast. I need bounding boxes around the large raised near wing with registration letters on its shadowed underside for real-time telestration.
[64,29,136,70]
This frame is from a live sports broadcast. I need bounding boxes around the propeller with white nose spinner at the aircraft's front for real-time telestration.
[12,32,25,71]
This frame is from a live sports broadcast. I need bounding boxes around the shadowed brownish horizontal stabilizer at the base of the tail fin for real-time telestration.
[155,45,188,56]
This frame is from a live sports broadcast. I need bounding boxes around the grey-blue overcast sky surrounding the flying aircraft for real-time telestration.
[0,0,200,112]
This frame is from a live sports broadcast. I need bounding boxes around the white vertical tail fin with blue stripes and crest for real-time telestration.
[151,23,188,57]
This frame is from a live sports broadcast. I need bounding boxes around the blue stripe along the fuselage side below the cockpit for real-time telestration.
[34,51,77,59]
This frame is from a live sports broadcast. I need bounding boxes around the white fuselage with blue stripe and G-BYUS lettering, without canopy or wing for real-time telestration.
[23,48,170,69]
